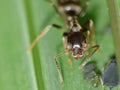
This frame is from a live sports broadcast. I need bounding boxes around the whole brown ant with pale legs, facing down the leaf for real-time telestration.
[28,0,99,85]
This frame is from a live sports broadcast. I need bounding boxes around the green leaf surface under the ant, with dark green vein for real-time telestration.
[0,0,118,90]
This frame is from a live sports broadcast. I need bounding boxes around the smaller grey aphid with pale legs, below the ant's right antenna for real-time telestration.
[83,63,101,87]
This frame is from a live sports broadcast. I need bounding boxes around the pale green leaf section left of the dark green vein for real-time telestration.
[0,0,37,90]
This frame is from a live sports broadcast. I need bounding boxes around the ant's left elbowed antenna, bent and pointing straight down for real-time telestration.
[54,50,69,86]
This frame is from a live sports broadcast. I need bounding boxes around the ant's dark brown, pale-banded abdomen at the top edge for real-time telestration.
[58,0,81,16]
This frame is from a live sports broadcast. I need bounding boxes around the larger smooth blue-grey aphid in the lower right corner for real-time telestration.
[102,56,119,90]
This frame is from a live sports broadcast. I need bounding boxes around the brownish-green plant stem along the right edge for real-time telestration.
[107,0,120,74]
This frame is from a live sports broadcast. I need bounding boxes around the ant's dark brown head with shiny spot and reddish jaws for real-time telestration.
[68,32,87,59]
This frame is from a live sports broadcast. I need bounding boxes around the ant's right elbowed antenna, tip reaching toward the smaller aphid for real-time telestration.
[79,45,99,69]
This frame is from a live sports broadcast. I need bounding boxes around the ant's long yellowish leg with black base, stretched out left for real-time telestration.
[28,24,63,51]
